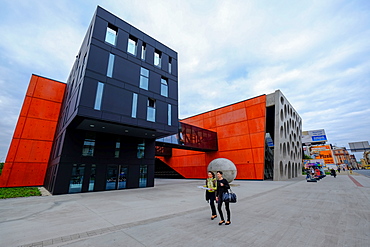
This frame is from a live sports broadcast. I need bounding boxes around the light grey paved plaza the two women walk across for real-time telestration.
[0,174,370,247]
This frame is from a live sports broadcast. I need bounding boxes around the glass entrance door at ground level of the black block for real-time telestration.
[105,165,128,190]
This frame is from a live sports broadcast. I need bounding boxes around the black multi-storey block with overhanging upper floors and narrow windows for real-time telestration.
[45,7,178,194]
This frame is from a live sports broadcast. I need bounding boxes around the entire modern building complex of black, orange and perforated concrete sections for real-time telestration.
[0,7,302,194]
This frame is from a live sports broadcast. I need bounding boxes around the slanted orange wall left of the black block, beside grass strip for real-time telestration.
[0,75,66,187]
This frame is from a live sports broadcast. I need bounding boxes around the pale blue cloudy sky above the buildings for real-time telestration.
[0,0,370,161]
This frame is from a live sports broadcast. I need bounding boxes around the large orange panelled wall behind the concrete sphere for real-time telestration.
[158,95,266,179]
